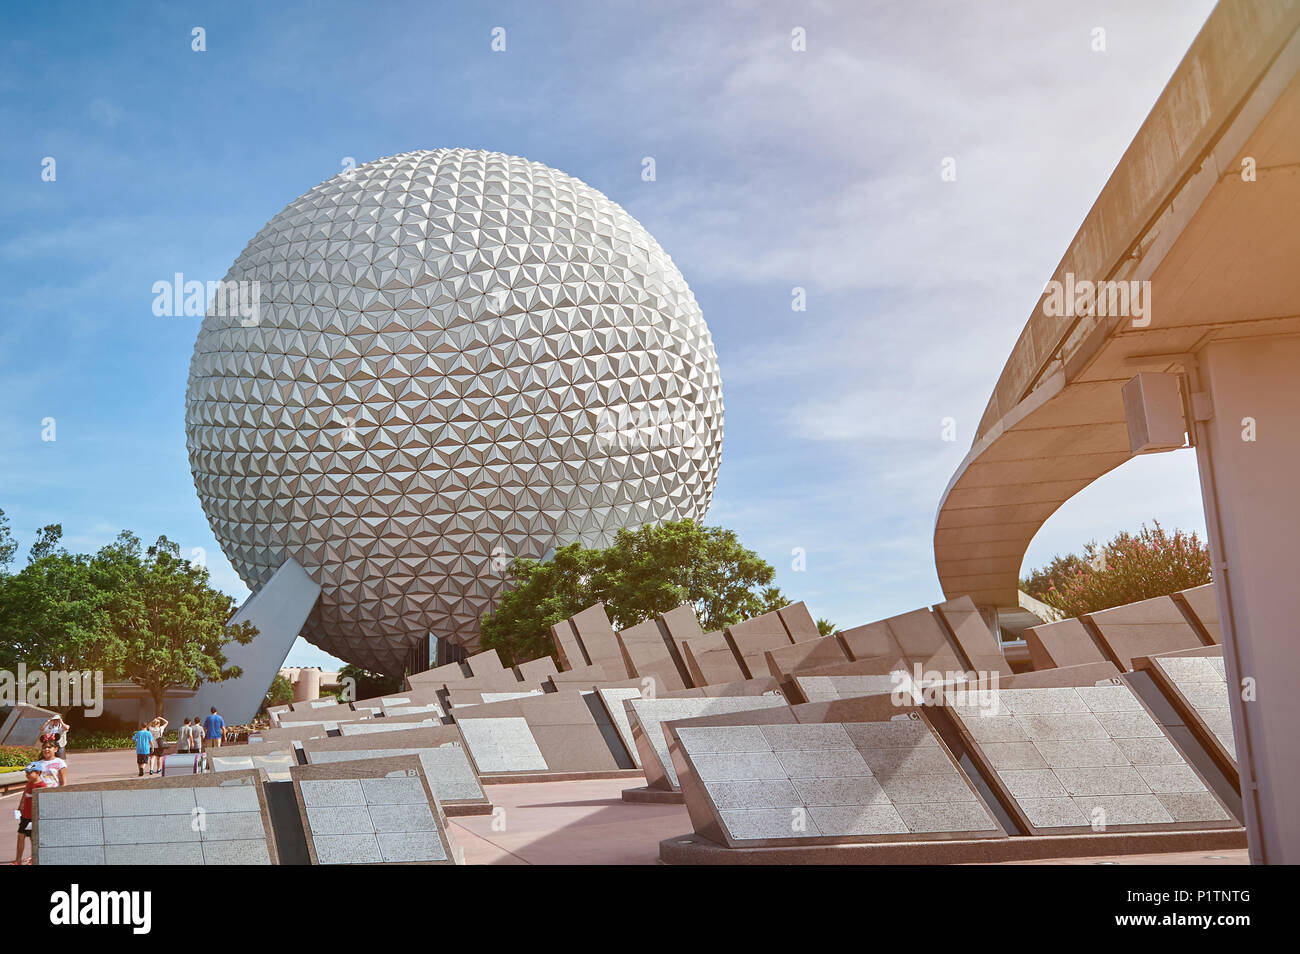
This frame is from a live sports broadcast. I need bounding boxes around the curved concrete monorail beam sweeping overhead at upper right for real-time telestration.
[935,0,1300,607]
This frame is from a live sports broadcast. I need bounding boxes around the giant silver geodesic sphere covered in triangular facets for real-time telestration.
[186,149,723,672]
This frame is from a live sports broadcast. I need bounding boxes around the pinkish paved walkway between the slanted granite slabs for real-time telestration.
[0,749,1248,864]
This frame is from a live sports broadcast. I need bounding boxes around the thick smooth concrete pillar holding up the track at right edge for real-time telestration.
[1190,337,1300,864]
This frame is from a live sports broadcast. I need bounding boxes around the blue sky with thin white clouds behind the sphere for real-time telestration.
[0,0,1213,667]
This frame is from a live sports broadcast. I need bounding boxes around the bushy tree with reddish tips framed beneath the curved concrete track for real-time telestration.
[1021,521,1210,616]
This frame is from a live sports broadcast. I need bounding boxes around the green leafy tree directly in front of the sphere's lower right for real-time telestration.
[480,520,788,662]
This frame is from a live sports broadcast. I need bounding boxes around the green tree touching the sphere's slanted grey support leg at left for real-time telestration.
[96,533,257,712]
